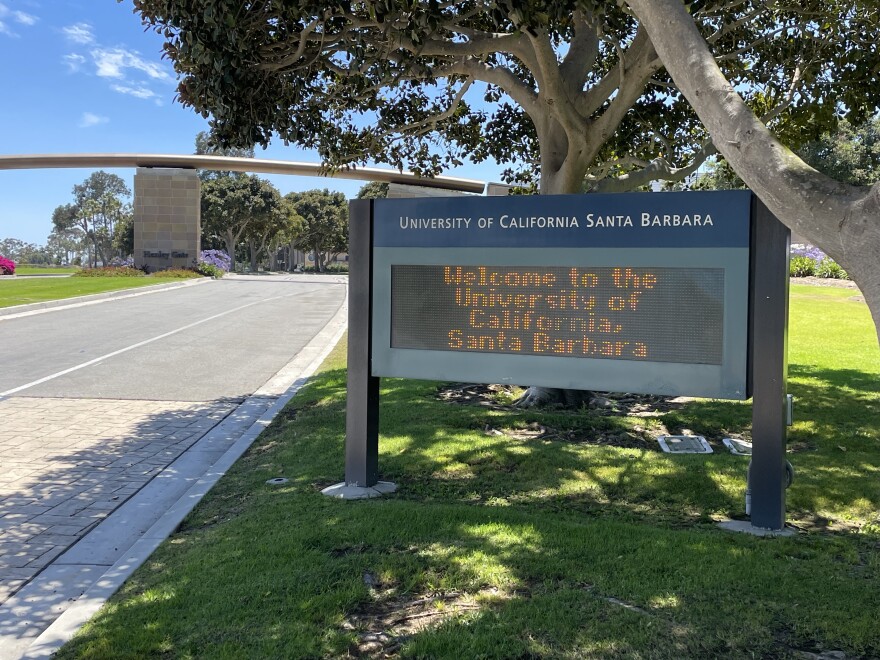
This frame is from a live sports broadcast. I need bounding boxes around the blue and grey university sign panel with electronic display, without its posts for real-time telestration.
[371,191,752,399]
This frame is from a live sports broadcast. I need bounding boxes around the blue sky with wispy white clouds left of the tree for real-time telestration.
[0,0,500,244]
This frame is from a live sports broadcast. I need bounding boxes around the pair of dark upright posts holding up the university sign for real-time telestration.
[345,193,790,530]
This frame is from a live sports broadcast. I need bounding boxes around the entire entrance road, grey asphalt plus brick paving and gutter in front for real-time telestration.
[0,276,346,658]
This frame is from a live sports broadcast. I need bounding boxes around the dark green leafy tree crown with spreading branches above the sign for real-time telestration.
[135,0,880,193]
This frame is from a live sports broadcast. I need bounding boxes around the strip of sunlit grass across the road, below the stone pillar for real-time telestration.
[0,276,198,307]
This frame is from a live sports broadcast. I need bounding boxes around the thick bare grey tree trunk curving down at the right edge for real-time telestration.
[628,0,880,346]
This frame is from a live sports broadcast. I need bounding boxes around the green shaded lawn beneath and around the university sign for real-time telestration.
[59,286,880,659]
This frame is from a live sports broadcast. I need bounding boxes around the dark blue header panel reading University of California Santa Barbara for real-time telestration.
[373,190,751,248]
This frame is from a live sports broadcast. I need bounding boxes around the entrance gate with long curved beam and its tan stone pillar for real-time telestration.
[0,154,486,269]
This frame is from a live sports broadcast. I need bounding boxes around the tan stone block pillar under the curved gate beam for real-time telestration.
[134,167,202,271]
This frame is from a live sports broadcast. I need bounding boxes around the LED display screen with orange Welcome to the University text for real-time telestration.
[391,265,724,365]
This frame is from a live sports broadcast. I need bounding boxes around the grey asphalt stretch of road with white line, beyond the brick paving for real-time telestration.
[0,276,345,401]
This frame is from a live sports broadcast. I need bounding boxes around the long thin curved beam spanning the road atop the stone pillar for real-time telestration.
[0,154,486,194]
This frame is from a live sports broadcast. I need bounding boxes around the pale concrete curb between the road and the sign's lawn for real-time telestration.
[20,291,348,660]
